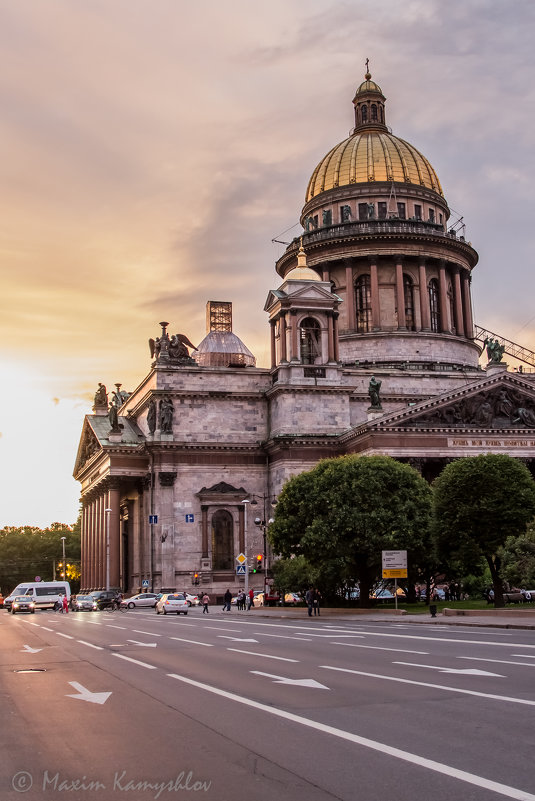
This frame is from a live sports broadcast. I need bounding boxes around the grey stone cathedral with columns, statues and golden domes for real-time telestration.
[74,72,535,597]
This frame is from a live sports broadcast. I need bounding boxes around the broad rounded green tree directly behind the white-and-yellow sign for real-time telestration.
[269,456,432,606]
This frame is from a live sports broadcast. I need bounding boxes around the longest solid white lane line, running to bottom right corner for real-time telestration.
[167,673,535,801]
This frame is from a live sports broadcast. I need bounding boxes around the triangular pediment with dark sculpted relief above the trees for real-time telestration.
[376,375,535,430]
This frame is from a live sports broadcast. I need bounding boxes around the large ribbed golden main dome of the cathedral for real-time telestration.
[306,130,444,202]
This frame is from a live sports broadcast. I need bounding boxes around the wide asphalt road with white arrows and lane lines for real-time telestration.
[0,608,535,801]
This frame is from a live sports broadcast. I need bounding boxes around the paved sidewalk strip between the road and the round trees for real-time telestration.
[245,606,535,630]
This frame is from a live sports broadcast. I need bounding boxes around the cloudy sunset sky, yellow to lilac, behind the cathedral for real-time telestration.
[0,0,535,528]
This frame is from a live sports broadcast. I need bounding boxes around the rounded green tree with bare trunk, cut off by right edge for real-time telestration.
[433,454,535,607]
